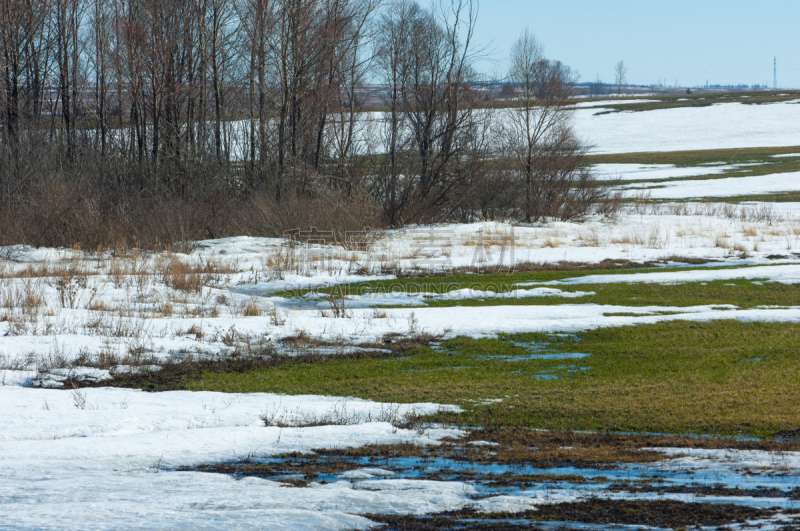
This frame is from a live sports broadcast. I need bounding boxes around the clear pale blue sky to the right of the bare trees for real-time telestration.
[456,0,800,88]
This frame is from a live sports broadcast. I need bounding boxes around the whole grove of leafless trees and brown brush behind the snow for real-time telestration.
[0,0,607,246]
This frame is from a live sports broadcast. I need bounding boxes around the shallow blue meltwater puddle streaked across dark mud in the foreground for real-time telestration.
[184,445,800,510]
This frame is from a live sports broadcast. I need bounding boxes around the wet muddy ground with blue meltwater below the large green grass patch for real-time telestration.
[181,428,800,530]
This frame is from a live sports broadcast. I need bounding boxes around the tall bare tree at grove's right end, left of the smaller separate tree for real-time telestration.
[376,0,479,223]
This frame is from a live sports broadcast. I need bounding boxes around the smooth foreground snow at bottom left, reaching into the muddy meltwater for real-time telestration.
[0,380,800,530]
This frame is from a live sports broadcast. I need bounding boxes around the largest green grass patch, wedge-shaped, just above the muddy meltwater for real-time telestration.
[185,321,800,437]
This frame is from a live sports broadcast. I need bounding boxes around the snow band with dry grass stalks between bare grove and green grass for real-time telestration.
[0,206,800,364]
